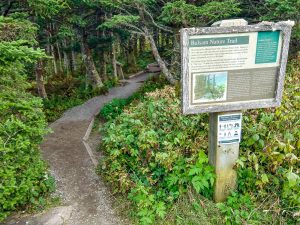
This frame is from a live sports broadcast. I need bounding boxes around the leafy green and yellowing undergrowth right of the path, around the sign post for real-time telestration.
[99,60,300,224]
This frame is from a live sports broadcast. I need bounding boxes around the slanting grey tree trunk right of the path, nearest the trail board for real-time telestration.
[144,27,176,85]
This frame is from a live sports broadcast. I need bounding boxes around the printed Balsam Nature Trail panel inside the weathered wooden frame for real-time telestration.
[188,31,282,105]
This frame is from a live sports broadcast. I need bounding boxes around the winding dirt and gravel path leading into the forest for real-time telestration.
[7,74,152,225]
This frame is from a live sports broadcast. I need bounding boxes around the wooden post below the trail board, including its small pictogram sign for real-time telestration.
[208,111,242,202]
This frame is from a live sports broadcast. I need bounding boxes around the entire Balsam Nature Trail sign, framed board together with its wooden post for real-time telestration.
[181,19,294,202]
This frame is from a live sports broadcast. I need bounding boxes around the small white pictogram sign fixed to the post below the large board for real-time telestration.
[218,113,242,144]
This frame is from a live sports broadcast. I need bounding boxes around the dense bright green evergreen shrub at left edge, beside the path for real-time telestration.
[0,67,54,221]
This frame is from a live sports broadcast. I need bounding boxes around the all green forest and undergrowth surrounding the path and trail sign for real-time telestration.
[0,0,300,224]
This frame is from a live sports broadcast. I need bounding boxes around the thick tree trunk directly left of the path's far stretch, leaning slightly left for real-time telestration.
[81,35,103,88]
